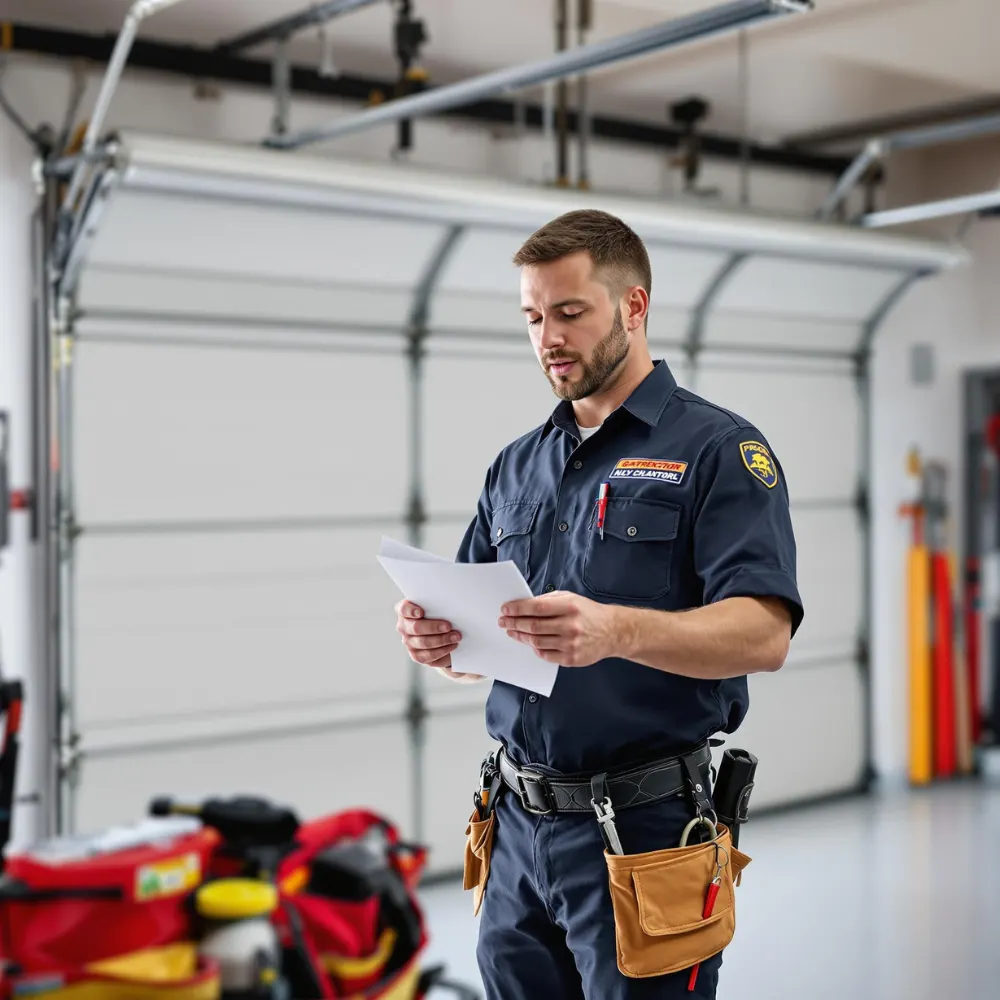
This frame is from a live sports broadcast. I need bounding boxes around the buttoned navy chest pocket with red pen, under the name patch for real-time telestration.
[583,497,681,601]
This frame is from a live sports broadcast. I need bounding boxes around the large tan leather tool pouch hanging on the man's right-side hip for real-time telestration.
[605,825,750,979]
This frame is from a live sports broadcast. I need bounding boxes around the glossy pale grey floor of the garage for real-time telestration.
[422,776,1000,1000]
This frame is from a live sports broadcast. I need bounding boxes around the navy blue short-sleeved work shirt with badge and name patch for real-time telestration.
[457,361,803,773]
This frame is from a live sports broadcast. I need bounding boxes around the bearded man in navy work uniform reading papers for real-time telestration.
[397,211,803,1000]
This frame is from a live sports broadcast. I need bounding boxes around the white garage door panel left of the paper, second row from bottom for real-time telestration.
[77,525,407,725]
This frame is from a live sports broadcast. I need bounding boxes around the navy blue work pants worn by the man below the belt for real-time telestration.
[476,790,722,1000]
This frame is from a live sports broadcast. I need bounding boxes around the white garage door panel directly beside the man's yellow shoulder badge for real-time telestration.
[696,364,860,503]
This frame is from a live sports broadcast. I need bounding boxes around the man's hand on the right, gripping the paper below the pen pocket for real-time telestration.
[499,590,616,667]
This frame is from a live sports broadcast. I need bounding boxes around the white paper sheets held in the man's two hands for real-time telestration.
[377,538,559,697]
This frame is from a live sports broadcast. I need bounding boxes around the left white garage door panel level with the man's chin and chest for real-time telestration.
[75,344,407,524]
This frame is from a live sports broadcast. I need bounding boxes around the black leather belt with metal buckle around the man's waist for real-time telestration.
[496,742,712,816]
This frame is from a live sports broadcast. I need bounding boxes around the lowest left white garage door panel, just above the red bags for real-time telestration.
[77,722,412,831]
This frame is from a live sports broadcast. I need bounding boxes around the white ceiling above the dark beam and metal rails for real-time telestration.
[7,0,1000,141]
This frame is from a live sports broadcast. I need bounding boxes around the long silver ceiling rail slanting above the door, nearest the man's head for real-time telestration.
[266,0,813,149]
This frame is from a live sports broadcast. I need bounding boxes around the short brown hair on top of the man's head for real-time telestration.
[514,208,653,295]
